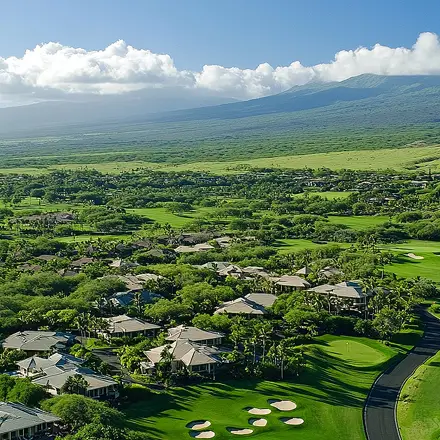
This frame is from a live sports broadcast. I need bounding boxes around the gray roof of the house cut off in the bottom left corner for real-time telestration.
[0,402,60,434]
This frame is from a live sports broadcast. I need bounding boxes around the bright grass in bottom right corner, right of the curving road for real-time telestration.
[397,353,440,440]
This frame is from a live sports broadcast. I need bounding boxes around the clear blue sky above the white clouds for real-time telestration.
[0,0,440,70]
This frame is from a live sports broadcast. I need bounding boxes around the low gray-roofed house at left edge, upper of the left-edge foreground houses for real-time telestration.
[2,330,75,355]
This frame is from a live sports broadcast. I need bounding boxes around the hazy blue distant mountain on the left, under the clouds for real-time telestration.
[0,88,236,133]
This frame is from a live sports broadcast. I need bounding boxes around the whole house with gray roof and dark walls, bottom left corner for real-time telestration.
[0,402,61,440]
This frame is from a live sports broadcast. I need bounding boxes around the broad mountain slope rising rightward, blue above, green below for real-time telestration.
[0,75,440,167]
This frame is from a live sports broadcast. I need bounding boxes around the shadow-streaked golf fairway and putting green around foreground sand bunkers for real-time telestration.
[125,330,420,440]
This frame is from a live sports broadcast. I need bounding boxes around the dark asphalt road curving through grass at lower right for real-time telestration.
[364,310,440,440]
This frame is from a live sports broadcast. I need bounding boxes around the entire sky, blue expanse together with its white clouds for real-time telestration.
[0,0,440,102]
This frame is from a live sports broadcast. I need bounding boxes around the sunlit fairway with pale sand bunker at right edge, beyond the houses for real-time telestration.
[382,240,440,282]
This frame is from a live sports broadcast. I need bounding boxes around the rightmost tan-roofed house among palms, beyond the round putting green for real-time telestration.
[309,281,371,312]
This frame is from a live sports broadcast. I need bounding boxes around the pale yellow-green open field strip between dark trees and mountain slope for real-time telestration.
[0,145,440,174]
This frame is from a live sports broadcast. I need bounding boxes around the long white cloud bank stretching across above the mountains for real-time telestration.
[0,32,440,101]
